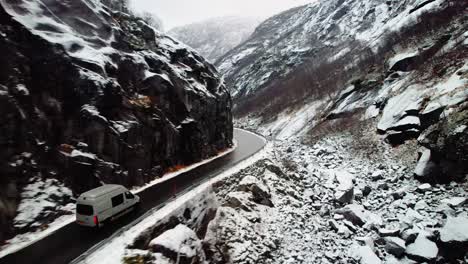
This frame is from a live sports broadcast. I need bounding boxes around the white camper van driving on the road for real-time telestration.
[76,184,140,227]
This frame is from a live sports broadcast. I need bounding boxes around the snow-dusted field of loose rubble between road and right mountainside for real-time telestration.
[97,131,467,264]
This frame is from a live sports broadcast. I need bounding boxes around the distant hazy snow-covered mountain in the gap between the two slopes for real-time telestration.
[168,16,260,61]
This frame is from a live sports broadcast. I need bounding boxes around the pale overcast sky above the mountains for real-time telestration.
[131,0,313,30]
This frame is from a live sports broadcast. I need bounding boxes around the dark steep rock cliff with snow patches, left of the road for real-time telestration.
[0,0,233,244]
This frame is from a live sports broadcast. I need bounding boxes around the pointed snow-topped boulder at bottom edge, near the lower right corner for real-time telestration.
[406,232,439,262]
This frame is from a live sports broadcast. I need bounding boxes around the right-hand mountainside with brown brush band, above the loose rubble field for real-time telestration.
[225,0,468,182]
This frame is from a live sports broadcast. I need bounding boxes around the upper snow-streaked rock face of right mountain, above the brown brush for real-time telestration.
[217,0,464,99]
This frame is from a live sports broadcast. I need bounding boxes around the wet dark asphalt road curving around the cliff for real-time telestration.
[0,129,265,264]
